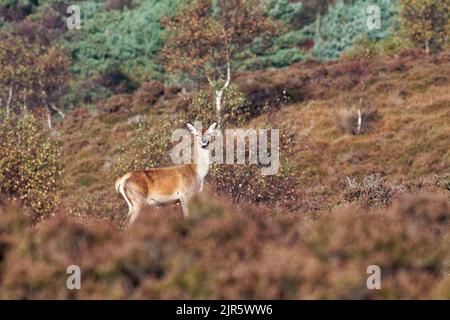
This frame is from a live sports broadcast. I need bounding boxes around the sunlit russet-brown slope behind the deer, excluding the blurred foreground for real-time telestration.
[62,51,450,213]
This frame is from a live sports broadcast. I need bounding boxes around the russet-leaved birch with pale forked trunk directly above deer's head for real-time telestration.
[161,0,277,125]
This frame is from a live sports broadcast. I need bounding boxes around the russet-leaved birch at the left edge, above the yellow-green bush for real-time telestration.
[0,34,69,129]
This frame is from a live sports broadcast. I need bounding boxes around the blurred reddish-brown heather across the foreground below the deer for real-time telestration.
[0,195,450,299]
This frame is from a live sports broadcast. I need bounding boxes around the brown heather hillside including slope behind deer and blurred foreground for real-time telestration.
[0,51,450,299]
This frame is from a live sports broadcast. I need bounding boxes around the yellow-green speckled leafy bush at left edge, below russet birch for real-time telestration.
[0,115,62,222]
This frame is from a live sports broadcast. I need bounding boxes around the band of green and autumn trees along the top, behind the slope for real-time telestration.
[0,0,450,105]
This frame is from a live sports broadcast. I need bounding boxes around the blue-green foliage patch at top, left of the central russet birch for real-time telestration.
[68,0,178,80]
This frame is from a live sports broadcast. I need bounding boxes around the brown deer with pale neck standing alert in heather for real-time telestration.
[115,122,217,227]
